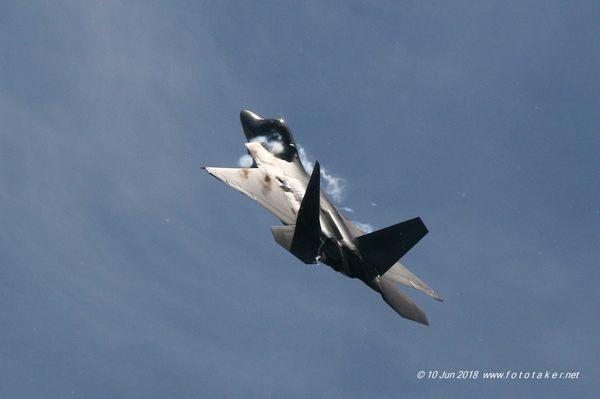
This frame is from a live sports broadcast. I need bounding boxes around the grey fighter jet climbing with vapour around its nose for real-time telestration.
[204,110,442,325]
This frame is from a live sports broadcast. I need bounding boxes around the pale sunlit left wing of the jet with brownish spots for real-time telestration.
[204,167,296,225]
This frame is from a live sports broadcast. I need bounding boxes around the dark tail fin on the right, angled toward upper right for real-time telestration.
[354,218,428,275]
